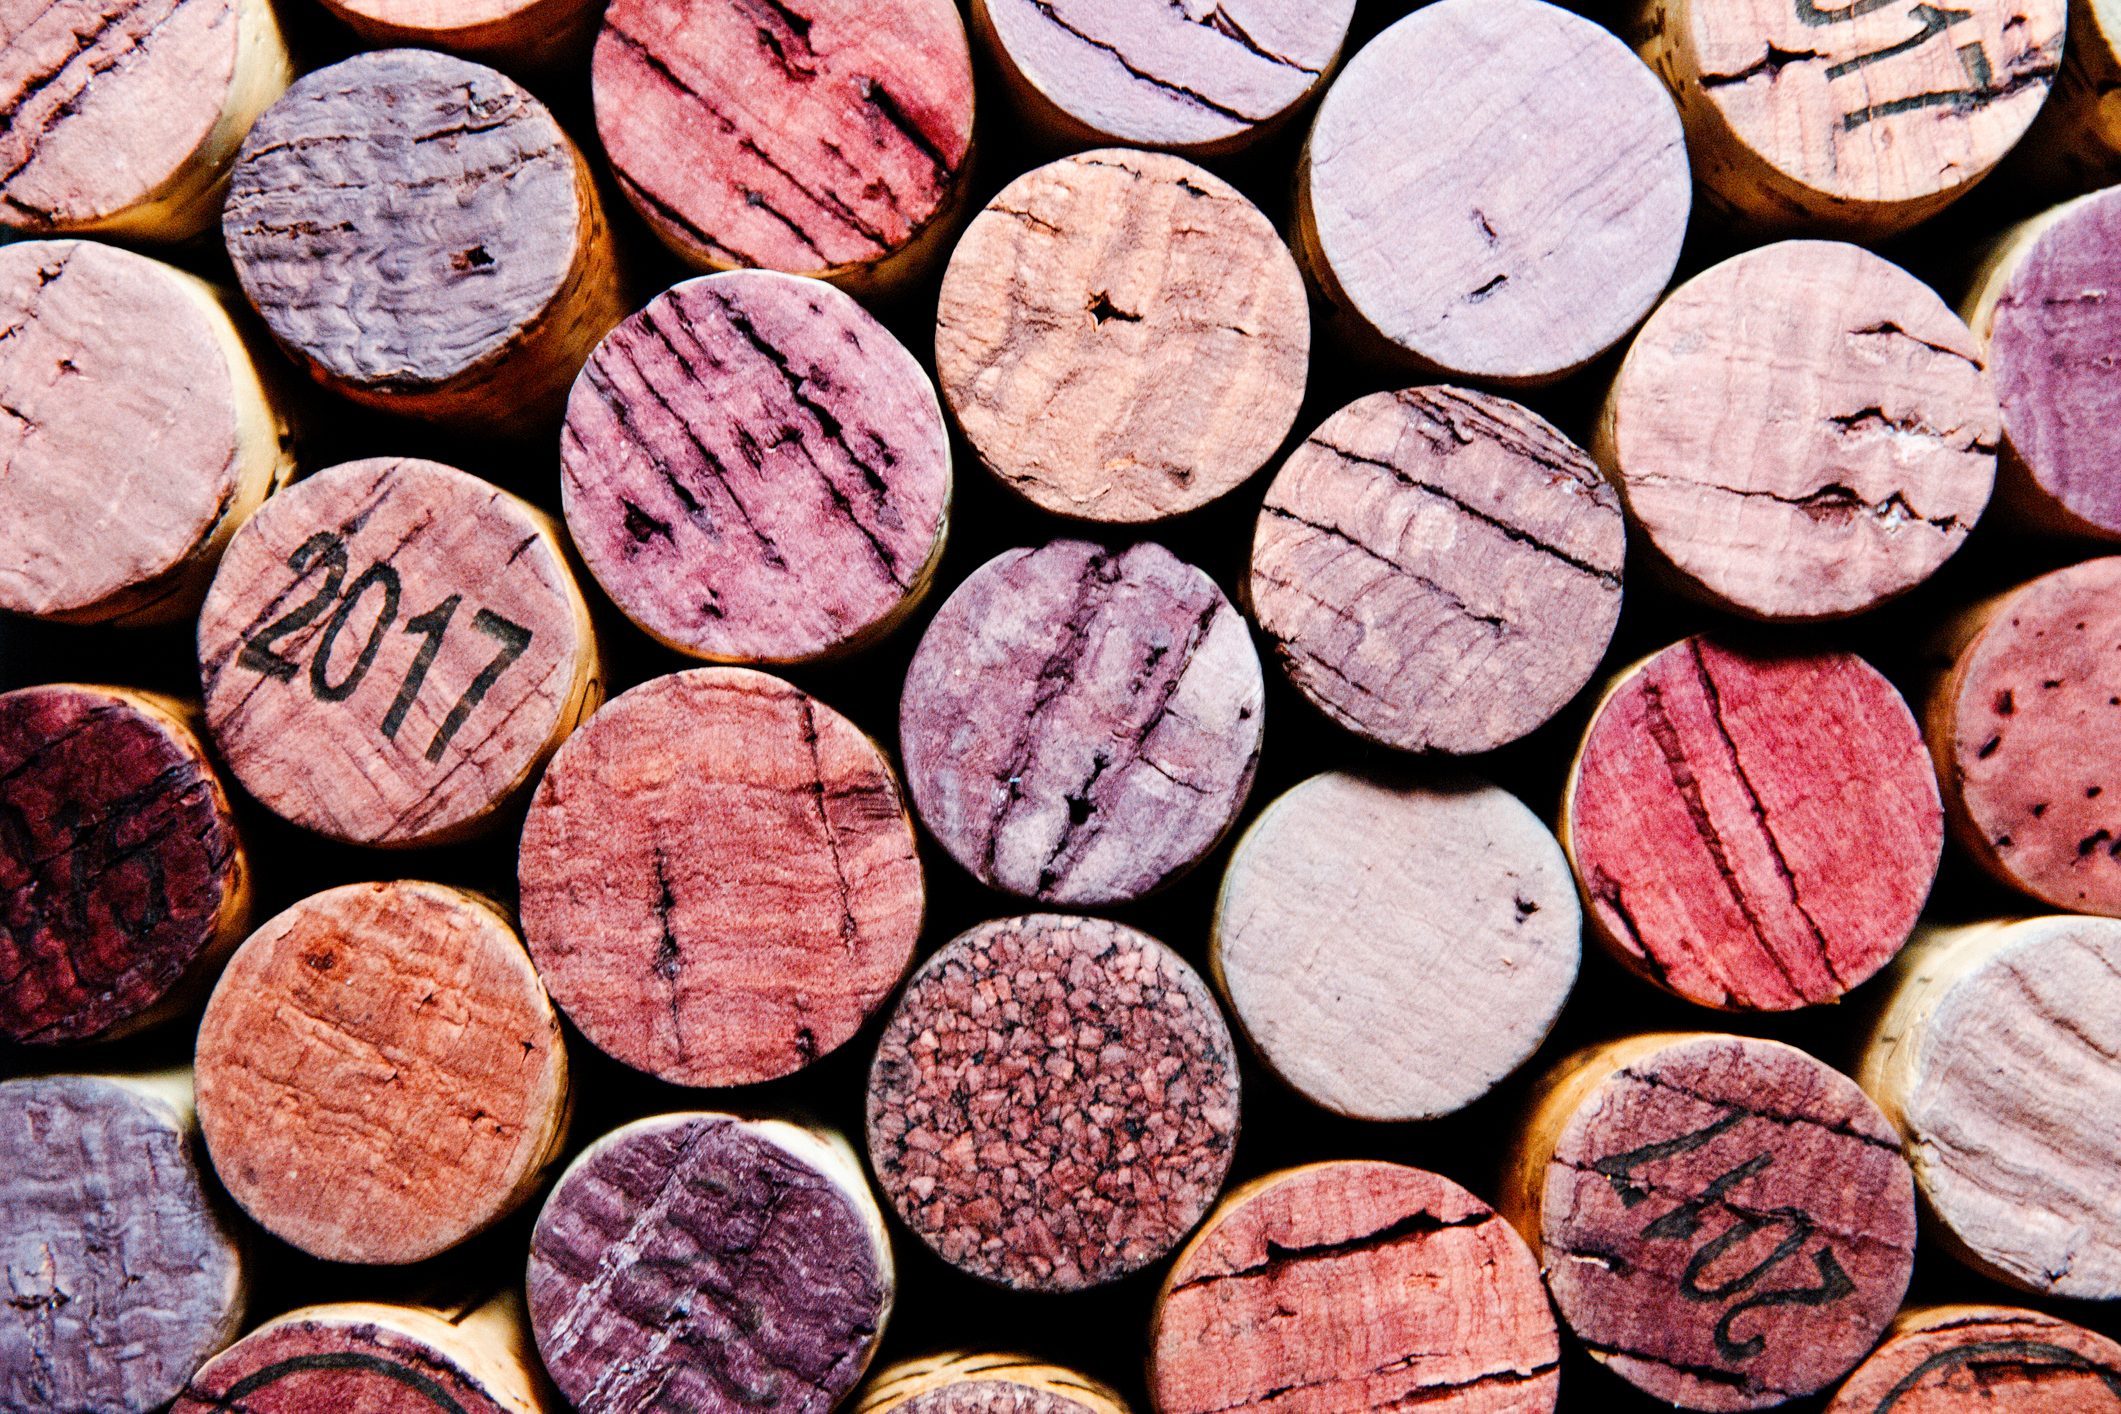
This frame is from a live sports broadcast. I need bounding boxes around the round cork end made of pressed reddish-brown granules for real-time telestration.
[870,914,1237,1291]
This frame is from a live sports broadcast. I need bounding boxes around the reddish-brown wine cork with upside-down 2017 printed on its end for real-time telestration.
[1497,1035,1915,1410]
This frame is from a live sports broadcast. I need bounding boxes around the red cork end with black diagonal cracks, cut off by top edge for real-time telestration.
[590,0,971,276]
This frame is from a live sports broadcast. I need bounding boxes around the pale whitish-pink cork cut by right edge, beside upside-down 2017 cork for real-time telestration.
[1858,916,2121,1300]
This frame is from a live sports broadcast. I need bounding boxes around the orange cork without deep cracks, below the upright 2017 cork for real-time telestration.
[197,882,568,1263]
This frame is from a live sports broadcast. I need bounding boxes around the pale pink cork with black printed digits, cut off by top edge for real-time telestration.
[1640,0,2068,240]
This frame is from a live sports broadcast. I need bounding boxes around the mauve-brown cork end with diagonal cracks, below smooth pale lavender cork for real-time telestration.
[1251,388,1627,755]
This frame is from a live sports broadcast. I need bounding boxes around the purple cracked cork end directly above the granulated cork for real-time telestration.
[899,541,1266,905]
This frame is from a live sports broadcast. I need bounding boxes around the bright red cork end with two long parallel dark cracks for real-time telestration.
[1561,638,1945,1011]
